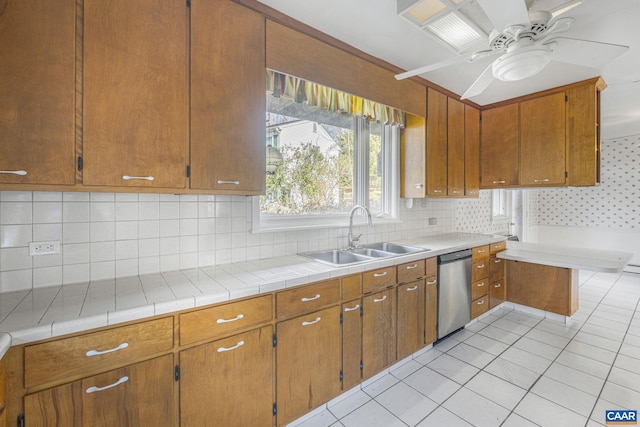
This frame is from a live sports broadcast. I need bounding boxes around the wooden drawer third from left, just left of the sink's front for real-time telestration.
[276,279,340,319]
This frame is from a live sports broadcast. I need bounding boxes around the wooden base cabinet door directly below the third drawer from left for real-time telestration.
[276,306,342,425]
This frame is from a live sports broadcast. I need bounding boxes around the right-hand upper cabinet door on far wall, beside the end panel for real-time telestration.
[520,92,567,186]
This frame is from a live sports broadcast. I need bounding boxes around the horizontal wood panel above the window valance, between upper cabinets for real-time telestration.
[267,20,426,117]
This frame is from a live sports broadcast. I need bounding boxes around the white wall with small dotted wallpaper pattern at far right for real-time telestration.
[530,135,640,264]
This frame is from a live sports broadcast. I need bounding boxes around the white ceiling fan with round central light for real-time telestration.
[395,0,629,99]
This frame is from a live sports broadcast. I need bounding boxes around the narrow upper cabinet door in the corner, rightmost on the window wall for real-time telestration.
[464,105,480,197]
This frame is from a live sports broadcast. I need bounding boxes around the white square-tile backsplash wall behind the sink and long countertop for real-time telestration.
[0,191,456,292]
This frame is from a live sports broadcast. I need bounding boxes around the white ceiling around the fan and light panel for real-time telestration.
[259,0,640,139]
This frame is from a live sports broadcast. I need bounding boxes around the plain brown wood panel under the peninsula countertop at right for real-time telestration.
[506,261,578,316]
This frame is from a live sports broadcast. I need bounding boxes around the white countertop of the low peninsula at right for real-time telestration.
[496,241,633,273]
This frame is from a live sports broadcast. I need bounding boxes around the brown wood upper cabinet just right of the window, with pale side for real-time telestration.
[400,88,480,198]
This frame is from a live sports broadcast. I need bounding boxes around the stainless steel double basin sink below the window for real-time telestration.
[300,242,430,266]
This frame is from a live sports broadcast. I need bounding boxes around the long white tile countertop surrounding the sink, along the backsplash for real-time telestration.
[0,233,505,358]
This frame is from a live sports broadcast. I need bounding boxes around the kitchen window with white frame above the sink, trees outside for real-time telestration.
[252,70,400,232]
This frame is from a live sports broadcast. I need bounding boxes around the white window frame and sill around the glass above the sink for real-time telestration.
[250,116,400,233]
